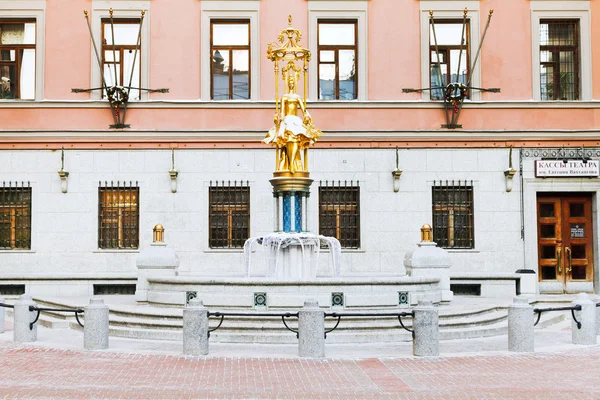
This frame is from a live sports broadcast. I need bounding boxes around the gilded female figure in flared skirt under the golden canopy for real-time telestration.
[263,61,322,174]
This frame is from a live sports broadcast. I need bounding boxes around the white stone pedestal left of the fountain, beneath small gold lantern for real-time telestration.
[135,242,179,303]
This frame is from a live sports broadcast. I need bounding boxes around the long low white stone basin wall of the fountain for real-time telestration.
[148,276,441,310]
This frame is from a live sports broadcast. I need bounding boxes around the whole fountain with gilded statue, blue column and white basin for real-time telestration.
[147,16,441,310]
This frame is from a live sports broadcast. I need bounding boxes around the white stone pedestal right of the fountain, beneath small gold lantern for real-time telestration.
[404,241,453,303]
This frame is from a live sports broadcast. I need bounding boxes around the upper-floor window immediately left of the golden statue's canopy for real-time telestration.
[210,21,250,100]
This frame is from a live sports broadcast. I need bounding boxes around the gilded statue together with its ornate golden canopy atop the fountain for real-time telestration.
[263,15,322,177]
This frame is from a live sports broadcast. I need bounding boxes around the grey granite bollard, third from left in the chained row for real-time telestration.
[183,299,208,356]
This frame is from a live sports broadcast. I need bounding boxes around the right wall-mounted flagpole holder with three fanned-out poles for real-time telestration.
[402,8,500,129]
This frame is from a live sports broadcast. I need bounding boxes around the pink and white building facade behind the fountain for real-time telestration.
[0,0,600,296]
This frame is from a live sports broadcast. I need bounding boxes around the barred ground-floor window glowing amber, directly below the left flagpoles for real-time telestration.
[98,182,140,250]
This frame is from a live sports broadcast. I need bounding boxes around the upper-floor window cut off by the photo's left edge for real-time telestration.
[0,19,37,100]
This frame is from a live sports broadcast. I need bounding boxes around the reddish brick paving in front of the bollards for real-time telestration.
[0,341,600,400]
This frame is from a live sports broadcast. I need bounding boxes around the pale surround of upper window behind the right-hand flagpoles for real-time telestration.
[419,0,481,101]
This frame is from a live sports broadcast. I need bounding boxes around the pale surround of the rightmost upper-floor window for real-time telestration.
[529,0,593,102]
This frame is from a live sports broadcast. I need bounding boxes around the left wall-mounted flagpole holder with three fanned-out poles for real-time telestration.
[71,8,169,129]
